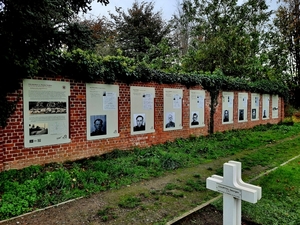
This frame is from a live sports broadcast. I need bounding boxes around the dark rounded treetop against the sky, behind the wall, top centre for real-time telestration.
[110,1,169,60]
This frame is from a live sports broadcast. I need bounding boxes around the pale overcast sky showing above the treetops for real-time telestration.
[84,0,277,21]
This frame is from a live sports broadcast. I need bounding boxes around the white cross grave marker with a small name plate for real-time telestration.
[206,161,262,225]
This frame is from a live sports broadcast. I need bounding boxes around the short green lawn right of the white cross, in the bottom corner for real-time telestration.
[242,158,300,225]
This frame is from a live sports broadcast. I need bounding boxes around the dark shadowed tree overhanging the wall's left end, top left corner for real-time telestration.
[0,0,109,126]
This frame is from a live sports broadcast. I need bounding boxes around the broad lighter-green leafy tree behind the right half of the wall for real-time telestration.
[183,0,271,80]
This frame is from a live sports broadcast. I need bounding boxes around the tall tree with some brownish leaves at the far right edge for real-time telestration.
[270,0,300,107]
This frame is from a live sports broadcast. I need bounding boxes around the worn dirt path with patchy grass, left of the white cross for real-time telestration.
[0,153,265,225]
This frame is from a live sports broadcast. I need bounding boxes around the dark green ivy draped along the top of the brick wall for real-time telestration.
[0,49,289,128]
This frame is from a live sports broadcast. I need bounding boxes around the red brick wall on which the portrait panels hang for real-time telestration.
[0,78,284,171]
